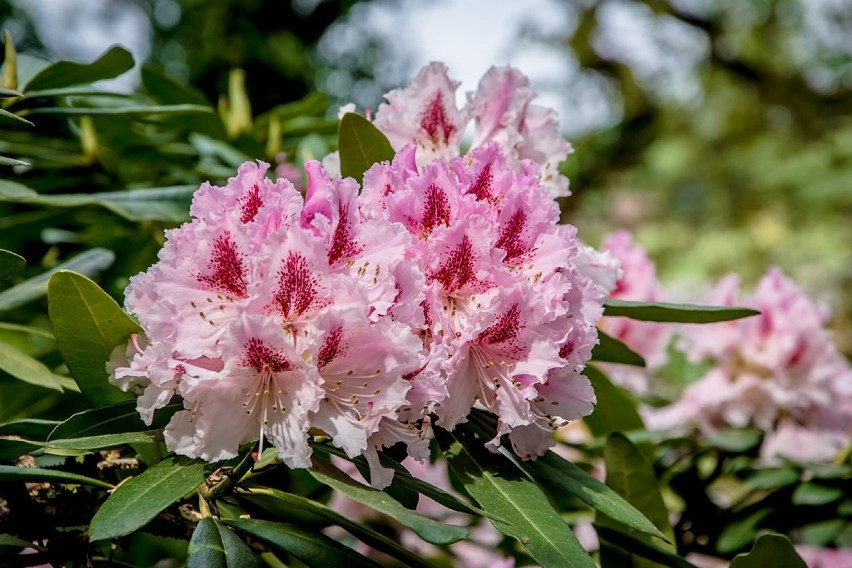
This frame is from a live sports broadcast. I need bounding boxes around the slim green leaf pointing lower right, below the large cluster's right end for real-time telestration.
[527,451,667,540]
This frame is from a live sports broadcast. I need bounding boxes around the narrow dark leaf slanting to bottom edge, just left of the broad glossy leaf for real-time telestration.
[239,486,430,568]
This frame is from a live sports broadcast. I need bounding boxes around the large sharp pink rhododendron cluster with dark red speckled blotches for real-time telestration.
[109,64,614,486]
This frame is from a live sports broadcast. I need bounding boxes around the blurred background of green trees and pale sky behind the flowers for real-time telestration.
[5,0,852,354]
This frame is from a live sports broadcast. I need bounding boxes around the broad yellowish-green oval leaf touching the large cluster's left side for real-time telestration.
[47,270,139,406]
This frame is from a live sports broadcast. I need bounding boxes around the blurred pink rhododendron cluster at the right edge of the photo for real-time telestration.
[646,269,852,462]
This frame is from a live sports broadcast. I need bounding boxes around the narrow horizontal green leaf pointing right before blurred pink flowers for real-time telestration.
[604,299,760,323]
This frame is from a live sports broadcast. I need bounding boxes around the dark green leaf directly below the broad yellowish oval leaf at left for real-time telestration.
[47,398,183,441]
